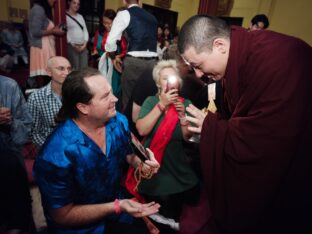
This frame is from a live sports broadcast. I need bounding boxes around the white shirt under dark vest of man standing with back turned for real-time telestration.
[105,4,158,57]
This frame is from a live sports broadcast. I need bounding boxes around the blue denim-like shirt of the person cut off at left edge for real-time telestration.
[0,76,31,153]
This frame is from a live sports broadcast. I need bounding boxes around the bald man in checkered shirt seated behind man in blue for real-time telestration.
[28,56,72,147]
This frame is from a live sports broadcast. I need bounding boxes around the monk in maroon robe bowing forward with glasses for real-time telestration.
[178,16,312,234]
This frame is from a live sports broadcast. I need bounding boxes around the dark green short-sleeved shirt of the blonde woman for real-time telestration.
[139,96,198,196]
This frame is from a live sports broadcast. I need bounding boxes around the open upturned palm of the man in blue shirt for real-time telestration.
[120,199,160,218]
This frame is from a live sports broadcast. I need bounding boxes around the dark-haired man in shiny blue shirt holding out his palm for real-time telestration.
[34,68,159,233]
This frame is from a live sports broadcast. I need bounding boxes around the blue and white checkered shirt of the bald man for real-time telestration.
[28,82,62,146]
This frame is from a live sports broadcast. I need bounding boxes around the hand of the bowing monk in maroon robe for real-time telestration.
[186,104,208,133]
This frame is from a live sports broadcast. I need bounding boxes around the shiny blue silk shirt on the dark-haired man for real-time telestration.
[33,113,132,233]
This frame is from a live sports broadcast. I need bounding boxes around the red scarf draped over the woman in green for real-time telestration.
[126,97,184,202]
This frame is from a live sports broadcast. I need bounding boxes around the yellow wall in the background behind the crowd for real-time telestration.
[0,0,312,46]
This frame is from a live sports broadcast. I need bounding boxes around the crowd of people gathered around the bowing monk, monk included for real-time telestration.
[0,0,312,234]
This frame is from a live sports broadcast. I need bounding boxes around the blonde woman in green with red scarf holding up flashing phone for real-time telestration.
[136,60,198,233]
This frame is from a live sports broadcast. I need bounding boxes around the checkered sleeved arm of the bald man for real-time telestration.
[28,93,45,146]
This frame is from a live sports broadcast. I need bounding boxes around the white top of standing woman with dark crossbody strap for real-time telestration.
[66,13,89,45]
